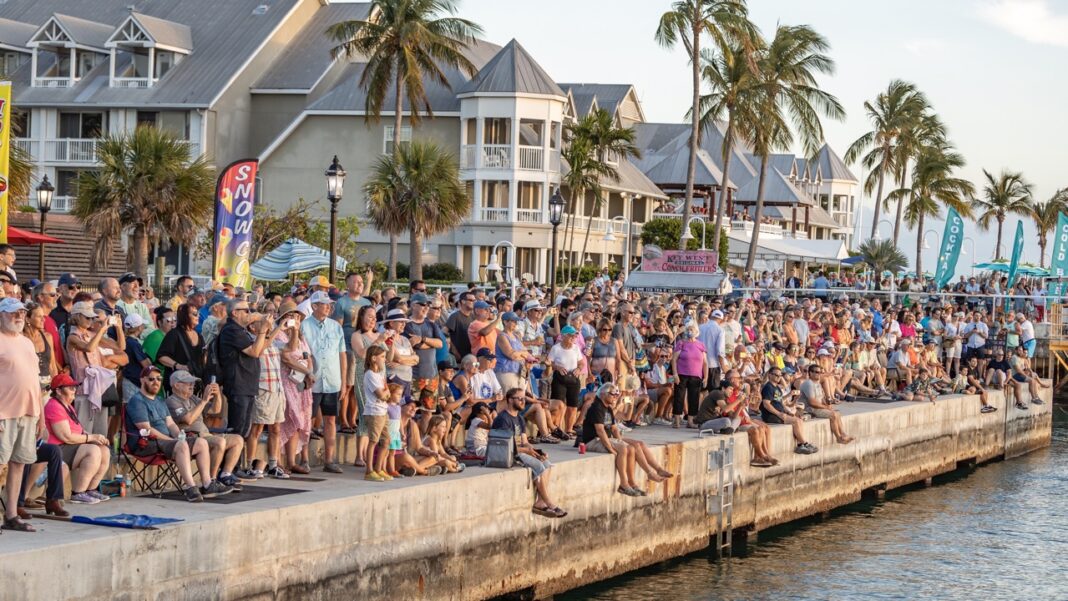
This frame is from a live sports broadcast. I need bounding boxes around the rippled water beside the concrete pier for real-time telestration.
[555,407,1068,601]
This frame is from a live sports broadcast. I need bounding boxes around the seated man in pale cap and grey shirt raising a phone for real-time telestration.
[164,369,245,492]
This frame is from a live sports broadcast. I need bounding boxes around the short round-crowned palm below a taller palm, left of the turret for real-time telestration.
[363,141,471,280]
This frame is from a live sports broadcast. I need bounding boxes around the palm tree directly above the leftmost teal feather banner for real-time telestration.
[891,142,975,276]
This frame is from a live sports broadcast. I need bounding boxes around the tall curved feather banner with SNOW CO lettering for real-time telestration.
[211,159,260,287]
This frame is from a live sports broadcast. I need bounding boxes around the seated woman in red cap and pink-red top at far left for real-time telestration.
[45,374,111,505]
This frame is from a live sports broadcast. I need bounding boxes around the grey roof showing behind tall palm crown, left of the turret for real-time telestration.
[308,39,501,113]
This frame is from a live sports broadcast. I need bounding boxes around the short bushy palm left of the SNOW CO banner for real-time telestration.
[72,126,215,278]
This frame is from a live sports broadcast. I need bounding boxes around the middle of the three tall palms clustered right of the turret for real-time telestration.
[698,42,759,254]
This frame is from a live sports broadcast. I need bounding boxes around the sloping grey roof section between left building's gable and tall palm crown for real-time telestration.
[252,3,371,90]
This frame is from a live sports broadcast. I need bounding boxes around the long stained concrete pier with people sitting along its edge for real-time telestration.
[0,390,1052,601]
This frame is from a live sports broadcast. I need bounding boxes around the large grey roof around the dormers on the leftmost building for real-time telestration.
[6,0,303,107]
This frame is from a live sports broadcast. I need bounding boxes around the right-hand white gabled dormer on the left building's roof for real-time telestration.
[105,12,192,88]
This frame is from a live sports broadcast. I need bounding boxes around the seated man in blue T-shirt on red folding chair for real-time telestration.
[125,365,232,503]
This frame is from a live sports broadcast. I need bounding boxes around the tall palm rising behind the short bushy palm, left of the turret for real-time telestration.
[327,0,482,280]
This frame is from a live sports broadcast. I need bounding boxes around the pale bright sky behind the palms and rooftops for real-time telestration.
[339,0,1068,273]
